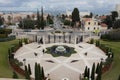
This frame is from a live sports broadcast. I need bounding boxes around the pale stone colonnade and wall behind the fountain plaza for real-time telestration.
[13,30,94,44]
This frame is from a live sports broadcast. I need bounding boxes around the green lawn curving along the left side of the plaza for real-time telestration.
[0,40,22,78]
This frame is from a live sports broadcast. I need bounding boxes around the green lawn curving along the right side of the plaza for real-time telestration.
[101,41,120,80]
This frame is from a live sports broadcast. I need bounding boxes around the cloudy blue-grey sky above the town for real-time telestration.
[0,0,120,13]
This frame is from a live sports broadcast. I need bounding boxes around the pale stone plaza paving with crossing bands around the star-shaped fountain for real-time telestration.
[15,43,106,80]
